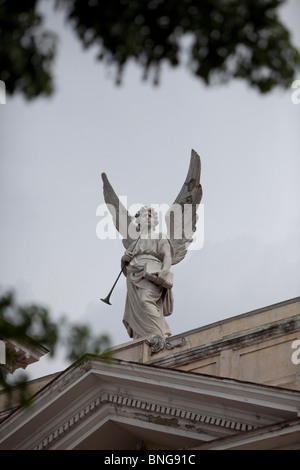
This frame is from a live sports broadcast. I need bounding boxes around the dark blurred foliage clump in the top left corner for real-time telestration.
[0,0,55,99]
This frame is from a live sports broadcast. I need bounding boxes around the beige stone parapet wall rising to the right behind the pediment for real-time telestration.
[114,298,300,390]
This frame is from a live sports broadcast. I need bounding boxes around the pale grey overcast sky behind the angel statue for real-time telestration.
[0,0,300,377]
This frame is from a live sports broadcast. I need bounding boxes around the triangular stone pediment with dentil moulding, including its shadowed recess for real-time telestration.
[0,356,300,450]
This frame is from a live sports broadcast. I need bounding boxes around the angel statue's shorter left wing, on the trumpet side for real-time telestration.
[101,173,137,249]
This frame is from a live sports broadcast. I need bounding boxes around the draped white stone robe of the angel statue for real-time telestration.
[123,234,173,339]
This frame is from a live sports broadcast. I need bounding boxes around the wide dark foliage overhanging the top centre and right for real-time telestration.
[58,0,300,92]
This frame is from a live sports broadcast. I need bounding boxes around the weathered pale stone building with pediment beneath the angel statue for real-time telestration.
[0,297,300,452]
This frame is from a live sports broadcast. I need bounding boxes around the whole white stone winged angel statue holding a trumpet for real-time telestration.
[102,150,202,353]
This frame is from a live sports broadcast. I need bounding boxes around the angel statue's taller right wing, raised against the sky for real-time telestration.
[165,150,202,265]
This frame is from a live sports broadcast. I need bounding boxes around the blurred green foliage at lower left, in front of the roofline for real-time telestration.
[0,292,111,406]
